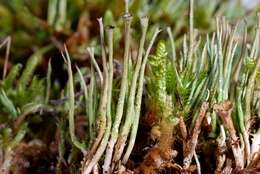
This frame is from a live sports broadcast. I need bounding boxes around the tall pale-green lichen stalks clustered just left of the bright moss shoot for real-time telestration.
[78,10,159,174]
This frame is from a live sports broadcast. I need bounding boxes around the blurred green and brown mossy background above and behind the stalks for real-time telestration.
[0,0,260,68]
